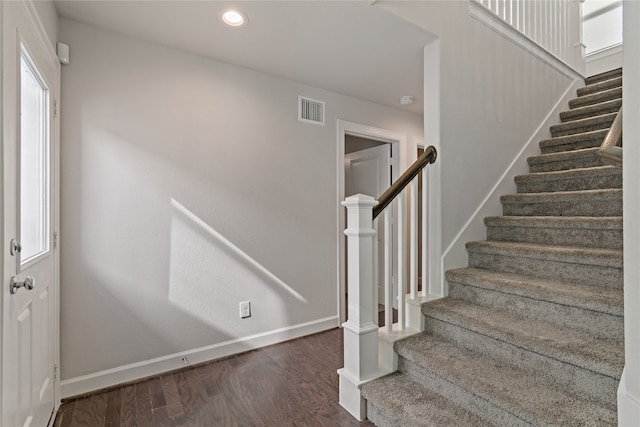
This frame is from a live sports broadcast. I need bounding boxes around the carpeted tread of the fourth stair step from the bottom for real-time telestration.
[446,267,624,316]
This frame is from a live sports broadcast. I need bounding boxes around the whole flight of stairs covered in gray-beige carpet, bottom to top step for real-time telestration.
[362,70,624,426]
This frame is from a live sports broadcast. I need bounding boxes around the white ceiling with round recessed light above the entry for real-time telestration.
[55,0,434,113]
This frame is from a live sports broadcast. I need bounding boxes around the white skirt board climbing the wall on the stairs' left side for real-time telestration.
[442,79,584,271]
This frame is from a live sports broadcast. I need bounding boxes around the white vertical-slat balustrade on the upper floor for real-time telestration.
[470,0,584,70]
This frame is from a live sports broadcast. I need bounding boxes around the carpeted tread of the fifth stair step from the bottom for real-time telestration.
[465,240,623,268]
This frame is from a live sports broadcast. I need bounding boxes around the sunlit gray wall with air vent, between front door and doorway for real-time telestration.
[59,20,422,379]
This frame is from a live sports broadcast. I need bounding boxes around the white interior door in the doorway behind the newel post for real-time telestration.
[344,144,393,314]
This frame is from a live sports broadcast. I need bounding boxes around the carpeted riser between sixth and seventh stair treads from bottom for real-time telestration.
[502,199,622,216]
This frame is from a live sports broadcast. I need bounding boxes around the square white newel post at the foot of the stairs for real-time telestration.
[338,194,378,420]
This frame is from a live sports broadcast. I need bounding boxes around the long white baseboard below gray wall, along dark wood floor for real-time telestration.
[60,316,340,398]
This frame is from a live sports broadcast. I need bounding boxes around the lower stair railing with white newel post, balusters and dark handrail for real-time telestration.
[338,146,437,420]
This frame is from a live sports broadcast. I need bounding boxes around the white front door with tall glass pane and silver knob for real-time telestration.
[1,1,60,427]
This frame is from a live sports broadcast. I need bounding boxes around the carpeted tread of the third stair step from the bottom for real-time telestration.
[422,298,624,379]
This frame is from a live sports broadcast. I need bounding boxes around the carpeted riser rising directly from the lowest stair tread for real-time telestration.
[398,357,531,427]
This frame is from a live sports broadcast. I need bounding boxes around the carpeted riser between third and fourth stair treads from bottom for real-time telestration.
[449,282,624,339]
